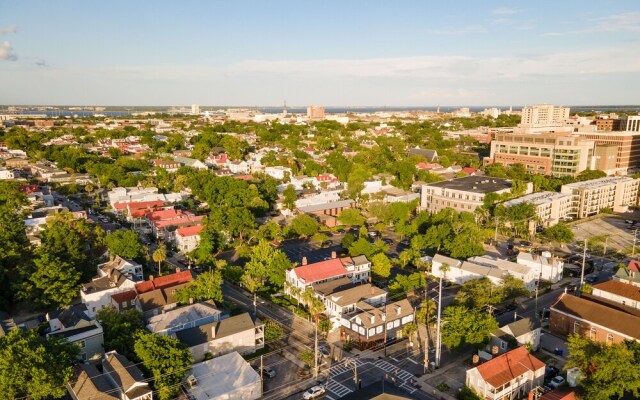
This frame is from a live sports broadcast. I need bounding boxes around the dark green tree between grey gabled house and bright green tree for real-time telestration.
[96,307,144,361]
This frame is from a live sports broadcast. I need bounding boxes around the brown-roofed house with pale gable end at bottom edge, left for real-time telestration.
[102,351,153,400]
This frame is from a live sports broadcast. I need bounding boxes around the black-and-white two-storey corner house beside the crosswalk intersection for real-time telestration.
[340,299,414,349]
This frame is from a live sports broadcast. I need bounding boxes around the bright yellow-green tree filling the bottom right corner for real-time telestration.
[565,334,640,400]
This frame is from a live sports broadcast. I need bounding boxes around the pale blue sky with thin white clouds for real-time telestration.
[0,0,640,107]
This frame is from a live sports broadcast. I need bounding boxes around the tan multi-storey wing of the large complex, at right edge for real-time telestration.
[574,130,640,175]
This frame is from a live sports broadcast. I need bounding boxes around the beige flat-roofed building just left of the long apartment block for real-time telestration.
[502,192,572,232]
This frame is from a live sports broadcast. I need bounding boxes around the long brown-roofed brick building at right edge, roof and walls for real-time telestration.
[549,293,640,343]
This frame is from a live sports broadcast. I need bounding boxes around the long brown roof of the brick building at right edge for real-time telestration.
[551,293,640,339]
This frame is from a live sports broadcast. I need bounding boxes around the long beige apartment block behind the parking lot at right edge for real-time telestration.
[560,176,640,218]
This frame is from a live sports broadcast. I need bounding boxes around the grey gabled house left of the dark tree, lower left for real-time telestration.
[46,304,104,361]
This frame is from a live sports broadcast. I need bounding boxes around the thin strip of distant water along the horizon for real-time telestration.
[10,105,640,118]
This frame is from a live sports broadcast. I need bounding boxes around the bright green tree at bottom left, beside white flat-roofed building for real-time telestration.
[134,331,193,400]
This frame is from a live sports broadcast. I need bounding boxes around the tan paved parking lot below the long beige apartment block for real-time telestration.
[571,217,640,252]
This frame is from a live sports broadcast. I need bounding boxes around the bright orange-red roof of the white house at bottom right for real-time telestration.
[477,346,544,388]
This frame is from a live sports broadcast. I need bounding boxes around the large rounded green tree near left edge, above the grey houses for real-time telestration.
[24,255,82,308]
